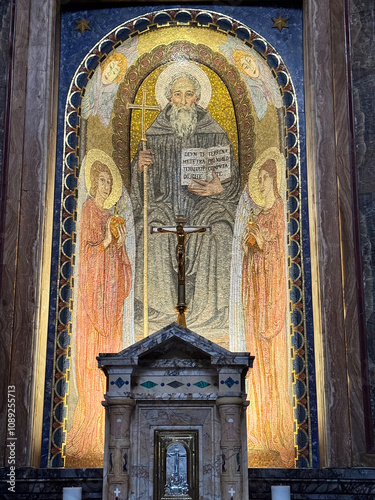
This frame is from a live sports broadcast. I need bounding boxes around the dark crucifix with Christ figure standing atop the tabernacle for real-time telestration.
[151,215,211,327]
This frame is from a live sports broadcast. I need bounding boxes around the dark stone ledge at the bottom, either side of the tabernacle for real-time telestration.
[0,467,375,500]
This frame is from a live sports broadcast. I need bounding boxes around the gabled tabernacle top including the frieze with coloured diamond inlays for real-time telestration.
[97,323,253,400]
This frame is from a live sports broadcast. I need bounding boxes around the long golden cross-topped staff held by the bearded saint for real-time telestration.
[127,89,160,337]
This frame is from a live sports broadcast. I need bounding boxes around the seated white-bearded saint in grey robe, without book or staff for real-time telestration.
[131,63,240,344]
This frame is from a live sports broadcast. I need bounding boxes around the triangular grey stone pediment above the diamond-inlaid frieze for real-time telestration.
[97,323,253,370]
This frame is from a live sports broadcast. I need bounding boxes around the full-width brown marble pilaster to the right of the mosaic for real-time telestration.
[304,0,364,467]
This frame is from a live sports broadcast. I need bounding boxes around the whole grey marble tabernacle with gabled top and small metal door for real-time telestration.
[97,323,253,500]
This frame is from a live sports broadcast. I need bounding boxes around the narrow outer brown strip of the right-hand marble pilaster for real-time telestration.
[331,2,365,465]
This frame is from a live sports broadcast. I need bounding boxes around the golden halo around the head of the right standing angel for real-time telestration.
[248,148,286,207]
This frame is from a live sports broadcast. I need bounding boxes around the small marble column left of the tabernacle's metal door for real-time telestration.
[103,398,135,500]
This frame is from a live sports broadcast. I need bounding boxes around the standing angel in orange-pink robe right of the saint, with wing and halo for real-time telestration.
[230,148,294,467]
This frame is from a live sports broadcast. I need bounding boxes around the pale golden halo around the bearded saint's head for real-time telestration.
[155,61,212,109]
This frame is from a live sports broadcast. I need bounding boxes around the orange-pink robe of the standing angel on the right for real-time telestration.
[242,197,294,467]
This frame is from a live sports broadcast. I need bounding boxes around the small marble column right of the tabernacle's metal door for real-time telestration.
[216,397,247,500]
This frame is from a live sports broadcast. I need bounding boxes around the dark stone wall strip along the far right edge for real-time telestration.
[350,0,375,447]
